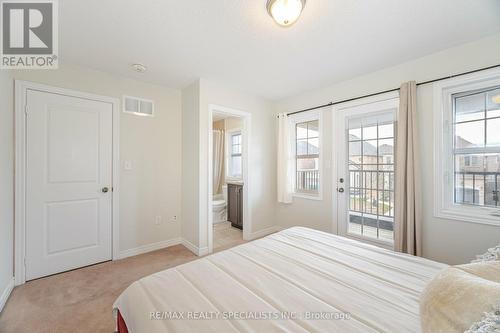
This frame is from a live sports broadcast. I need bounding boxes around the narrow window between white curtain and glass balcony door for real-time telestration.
[292,113,321,199]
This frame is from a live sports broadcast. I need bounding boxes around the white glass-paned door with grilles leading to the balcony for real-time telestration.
[336,98,399,247]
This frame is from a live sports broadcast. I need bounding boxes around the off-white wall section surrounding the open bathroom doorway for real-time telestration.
[182,79,276,249]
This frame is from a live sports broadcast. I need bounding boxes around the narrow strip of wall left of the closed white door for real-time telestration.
[0,70,14,306]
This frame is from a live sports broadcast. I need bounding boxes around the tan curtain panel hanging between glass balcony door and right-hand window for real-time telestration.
[394,81,422,256]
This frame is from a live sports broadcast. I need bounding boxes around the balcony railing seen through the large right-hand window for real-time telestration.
[455,171,500,207]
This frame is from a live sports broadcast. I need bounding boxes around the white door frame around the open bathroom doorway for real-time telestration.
[206,104,252,253]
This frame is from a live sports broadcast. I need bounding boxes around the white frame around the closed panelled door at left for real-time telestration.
[14,80,120,285]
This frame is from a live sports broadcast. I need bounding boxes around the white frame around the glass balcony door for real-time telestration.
[332,91,399,249]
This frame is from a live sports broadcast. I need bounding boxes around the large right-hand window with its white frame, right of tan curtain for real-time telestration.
[434,70,500,225]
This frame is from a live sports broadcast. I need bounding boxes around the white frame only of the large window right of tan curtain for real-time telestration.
[434,69,500,226]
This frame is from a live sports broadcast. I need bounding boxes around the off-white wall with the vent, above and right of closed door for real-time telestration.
[12,66,181,255]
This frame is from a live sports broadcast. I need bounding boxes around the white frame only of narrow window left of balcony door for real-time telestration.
[288,110,324,200]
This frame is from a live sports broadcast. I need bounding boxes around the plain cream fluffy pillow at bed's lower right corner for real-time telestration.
[420,261,500,333]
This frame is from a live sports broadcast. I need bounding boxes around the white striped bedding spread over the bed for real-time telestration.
[114,227,447,333]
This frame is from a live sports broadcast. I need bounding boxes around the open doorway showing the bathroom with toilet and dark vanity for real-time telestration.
[208,107,250,252]
